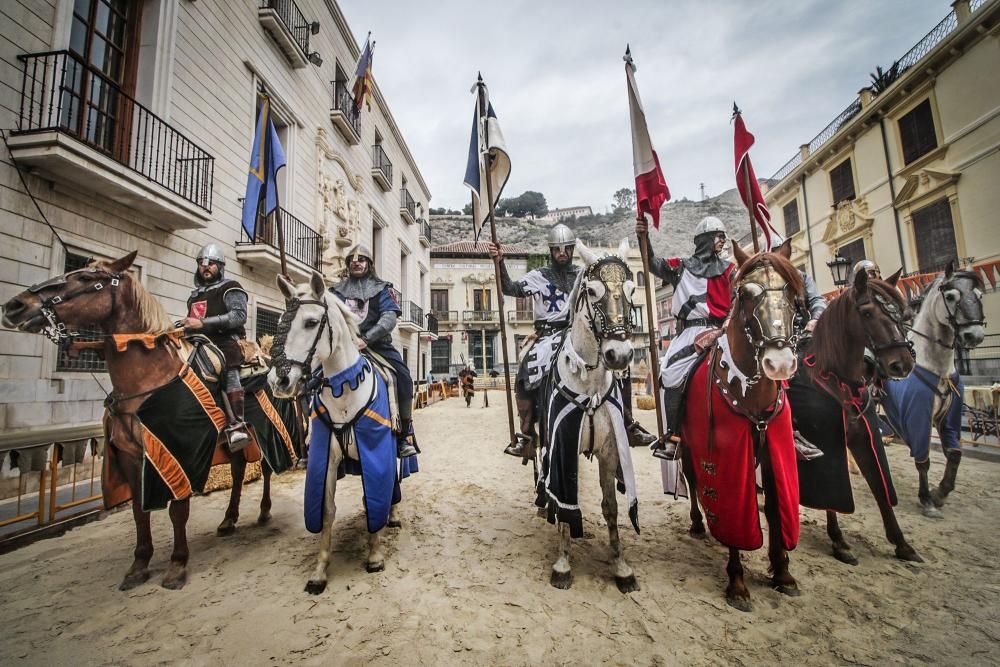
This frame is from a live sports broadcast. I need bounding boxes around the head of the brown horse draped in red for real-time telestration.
[730,241,805,381]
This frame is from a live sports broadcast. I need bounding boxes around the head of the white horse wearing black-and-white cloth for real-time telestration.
[570,239,635,371]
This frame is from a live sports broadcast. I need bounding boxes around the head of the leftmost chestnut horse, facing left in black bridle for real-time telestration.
[3,252,136,342]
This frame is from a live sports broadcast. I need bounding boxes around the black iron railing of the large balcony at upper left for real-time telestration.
[15,51,215,212]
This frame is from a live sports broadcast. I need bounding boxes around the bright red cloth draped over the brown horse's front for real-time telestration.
[681,357,799,551]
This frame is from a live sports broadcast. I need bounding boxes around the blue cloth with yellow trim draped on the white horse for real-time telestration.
[304,356,418,533]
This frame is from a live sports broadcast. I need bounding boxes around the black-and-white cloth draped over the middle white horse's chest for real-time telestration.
[535,369,639,538]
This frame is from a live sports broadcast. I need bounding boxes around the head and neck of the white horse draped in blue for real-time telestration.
[267,271,358,398]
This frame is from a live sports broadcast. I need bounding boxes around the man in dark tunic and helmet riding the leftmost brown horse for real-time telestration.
[180,243,250,452]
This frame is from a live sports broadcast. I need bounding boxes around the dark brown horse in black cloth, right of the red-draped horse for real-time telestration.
[788,271,922,565]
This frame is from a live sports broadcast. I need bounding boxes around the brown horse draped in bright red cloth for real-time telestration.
[681,242,803,611]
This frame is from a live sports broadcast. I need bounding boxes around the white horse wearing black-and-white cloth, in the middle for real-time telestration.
[537,240,639,593]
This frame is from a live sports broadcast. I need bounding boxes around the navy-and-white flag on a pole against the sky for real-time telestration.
[465,76,510,244]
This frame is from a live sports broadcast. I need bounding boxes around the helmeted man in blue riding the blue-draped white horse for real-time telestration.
[330,243,417,458]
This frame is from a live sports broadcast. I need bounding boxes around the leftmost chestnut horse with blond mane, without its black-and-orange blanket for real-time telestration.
[3,252,280,590]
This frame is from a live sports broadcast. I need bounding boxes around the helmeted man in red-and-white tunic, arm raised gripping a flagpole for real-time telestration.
[635,216,737,460]
